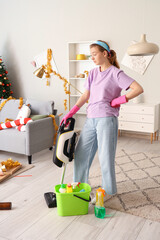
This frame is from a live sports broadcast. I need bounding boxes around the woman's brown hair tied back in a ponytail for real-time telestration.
[90,40,120,68]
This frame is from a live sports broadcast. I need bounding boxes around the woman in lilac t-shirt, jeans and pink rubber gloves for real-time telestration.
[61,40,143,202]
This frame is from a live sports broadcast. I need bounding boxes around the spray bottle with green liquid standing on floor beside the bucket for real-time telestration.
[94,188,106,218]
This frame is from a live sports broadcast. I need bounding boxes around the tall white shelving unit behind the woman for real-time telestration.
[68,41,96,129]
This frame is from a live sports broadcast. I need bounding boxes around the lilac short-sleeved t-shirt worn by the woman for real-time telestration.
[85,65,134,118]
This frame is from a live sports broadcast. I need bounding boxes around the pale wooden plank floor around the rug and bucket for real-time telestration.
[0,136,160,240]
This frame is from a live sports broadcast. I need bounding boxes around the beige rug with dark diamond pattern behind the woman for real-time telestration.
[90,150,160,222]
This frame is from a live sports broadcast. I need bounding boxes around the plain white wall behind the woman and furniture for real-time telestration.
[0,0,160,116]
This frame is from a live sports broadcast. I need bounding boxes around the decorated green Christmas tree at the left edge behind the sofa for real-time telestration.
[0,57,13,99]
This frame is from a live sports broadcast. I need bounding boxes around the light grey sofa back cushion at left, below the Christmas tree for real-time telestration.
[0,99,25,122]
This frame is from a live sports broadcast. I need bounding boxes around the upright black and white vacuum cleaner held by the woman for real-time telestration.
[44,118,78,208]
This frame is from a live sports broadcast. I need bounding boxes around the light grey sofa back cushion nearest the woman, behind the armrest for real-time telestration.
[26,98,54,115]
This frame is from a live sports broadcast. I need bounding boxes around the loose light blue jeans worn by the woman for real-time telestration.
[74,116,118,194]
